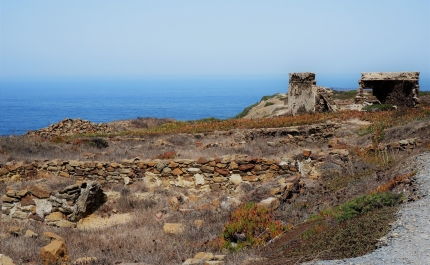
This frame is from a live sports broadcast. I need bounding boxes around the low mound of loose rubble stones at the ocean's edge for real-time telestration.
[27,119,112,138]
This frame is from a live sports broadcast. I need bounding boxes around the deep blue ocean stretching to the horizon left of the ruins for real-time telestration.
[0,75,288,135]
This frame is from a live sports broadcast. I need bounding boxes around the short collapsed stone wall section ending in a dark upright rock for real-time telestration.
[2,179,104,227]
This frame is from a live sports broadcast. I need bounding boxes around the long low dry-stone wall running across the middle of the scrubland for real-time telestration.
[0,155,298,190]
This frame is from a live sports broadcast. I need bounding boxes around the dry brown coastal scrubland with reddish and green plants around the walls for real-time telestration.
[0,92,430,264]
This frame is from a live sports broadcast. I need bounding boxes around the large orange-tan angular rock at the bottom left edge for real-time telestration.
[40,239,70,265]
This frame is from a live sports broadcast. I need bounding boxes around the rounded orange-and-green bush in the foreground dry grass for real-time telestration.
[221,202,286,251]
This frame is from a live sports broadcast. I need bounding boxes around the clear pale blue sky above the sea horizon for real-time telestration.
[0,0,430,87]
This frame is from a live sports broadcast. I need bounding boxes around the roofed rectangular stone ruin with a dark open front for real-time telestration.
[355,72,420,107]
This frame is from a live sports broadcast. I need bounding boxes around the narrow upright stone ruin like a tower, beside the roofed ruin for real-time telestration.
[288,72,337,115]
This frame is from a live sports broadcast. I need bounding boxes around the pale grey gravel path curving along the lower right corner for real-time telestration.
[306,153,430,265]
